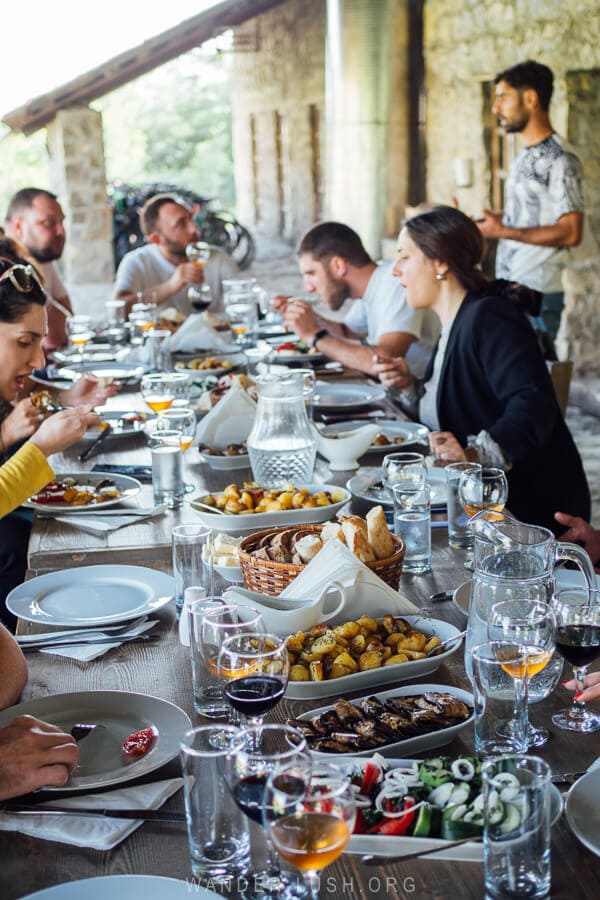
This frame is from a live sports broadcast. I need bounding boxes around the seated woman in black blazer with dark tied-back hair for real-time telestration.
[376,206,590,533]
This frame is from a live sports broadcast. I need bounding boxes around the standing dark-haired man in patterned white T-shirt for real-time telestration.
[477,60,584,338]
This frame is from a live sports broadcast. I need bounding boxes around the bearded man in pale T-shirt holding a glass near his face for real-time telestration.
[115,194,239,315]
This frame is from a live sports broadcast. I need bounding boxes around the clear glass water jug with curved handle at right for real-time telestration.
[465,510,596,680]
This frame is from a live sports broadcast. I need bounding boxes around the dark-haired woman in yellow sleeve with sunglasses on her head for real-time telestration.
[0,256,98,516]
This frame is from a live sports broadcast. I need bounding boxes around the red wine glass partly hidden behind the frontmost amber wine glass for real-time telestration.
[225,724,311,900]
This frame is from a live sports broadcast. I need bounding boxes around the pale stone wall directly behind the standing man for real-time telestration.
[425,0,600,374]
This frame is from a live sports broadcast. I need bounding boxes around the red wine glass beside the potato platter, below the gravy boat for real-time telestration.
[219,632,290,726]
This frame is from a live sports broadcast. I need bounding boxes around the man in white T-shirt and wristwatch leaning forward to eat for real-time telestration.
[274,222,439,375]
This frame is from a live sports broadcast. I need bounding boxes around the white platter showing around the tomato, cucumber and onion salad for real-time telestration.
[342,757,562,863]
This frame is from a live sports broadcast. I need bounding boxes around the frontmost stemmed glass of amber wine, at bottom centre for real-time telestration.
[263,760,356,900]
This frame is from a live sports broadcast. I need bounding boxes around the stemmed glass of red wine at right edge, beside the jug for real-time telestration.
[552,587,600,734]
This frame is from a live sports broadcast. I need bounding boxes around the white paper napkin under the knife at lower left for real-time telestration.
[0,778,183,850]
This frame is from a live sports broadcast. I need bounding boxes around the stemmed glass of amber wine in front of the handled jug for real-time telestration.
[488,599,562,747]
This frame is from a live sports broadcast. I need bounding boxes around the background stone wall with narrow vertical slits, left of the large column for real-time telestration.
[232,0,325,240]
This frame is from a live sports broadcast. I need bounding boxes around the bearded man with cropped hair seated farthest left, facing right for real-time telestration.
[6,188,73,351]
